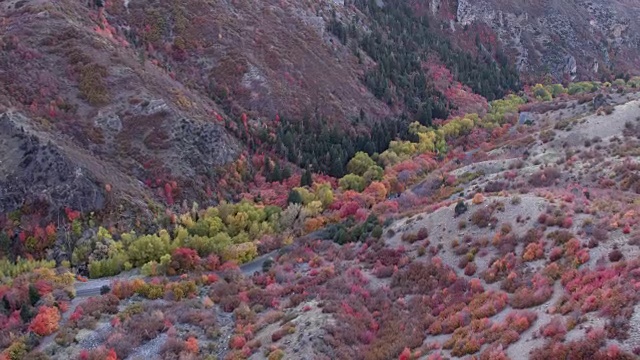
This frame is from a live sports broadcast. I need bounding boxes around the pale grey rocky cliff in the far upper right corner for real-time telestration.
[452,0,640,80]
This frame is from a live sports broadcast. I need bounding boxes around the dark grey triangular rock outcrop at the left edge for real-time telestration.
[0,113,105,217]
